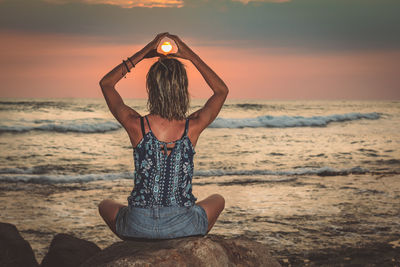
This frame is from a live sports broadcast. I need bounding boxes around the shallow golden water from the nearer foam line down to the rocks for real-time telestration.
[0,175,400,266]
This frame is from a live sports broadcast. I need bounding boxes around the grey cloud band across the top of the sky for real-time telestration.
[0,0,400,51]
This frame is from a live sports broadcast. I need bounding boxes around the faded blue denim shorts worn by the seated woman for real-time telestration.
[115,204,208,239]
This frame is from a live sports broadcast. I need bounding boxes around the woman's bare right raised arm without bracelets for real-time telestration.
[168,34,229,132]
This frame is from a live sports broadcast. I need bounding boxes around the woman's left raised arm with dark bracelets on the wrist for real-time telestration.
[100,33,168,128]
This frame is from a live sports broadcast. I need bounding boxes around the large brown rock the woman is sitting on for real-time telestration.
[81,235,280,267]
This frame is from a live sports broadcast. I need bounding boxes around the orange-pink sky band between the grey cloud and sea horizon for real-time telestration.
[0,31,400,99]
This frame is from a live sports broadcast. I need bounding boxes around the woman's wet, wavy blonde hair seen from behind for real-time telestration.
[146,58,190,121]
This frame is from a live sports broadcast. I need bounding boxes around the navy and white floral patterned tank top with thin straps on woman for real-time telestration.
[128,116,197,208]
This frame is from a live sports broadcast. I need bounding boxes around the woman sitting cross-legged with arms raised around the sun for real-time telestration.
[99,33,228,239]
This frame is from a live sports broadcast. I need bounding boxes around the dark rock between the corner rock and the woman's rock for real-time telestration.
[40,234,101,267]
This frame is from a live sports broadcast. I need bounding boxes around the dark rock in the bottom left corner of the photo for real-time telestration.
[0,222,38,267]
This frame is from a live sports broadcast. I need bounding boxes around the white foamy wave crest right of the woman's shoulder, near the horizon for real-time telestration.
[209,112,380,128]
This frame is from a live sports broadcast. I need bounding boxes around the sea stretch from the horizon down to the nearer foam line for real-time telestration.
[0,99,400,183]
